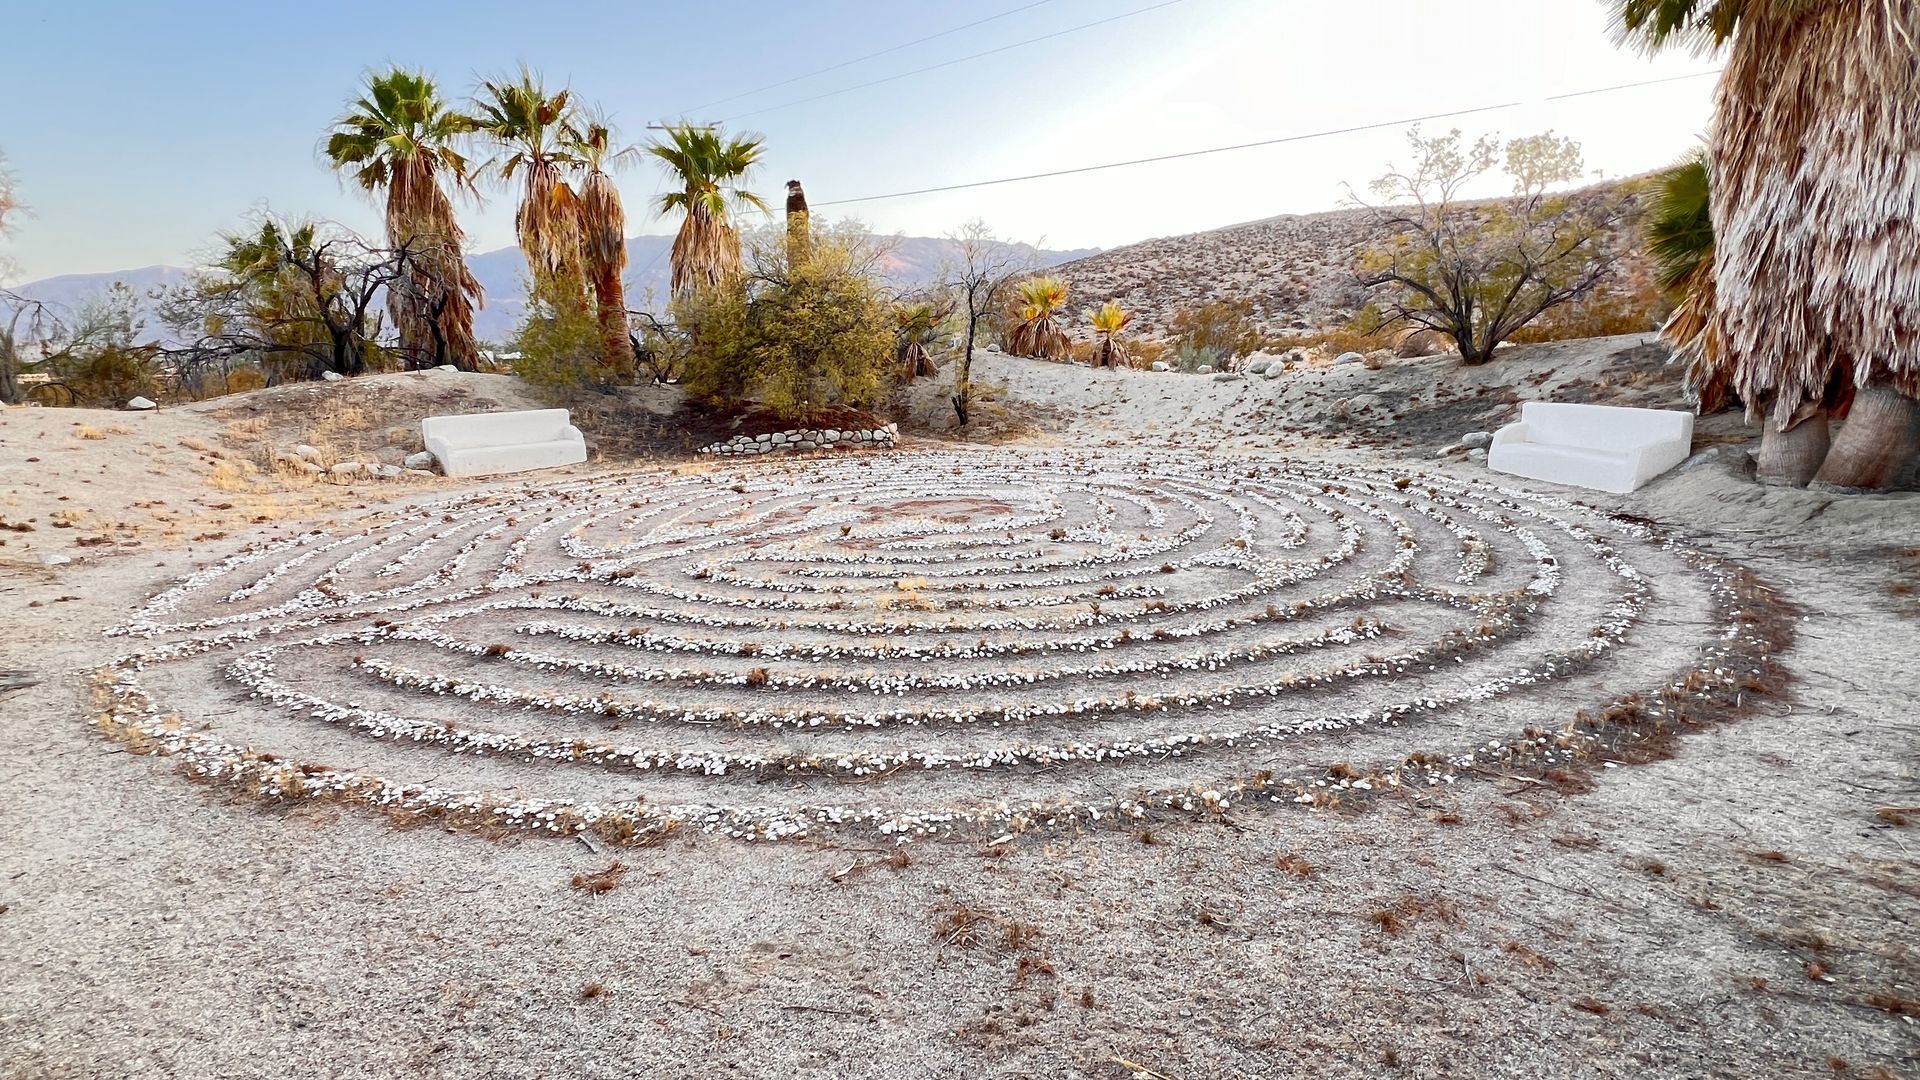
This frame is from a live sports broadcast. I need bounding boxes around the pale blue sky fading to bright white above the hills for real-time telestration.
[0,0,1716,281]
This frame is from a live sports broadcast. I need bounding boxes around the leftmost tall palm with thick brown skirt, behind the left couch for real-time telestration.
[326,67,482,371]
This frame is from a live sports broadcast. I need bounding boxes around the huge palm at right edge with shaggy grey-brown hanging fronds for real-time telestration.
[1613,0,1920,488]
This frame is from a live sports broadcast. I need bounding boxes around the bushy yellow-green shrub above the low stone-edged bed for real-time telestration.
[674,227,897,415]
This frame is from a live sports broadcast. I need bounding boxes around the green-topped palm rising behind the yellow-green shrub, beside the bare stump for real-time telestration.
[647,123,766,296]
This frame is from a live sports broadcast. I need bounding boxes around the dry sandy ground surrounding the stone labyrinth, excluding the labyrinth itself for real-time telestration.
[0,342,1920,1080]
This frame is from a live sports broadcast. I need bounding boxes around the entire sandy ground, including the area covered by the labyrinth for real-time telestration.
[0,338,1920,1080]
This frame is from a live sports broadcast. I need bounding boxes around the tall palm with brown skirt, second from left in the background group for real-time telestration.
[474,65,586,311]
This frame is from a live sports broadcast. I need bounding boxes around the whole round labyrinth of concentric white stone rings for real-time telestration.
[102,452,1788,842]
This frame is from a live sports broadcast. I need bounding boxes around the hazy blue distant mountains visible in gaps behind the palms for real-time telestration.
[13,236,1098,342]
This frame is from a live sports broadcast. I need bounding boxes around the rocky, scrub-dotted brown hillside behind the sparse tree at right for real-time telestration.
[1058,181,1649,336]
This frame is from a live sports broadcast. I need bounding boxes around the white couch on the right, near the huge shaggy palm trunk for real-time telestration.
[1486,402,1693,494]
